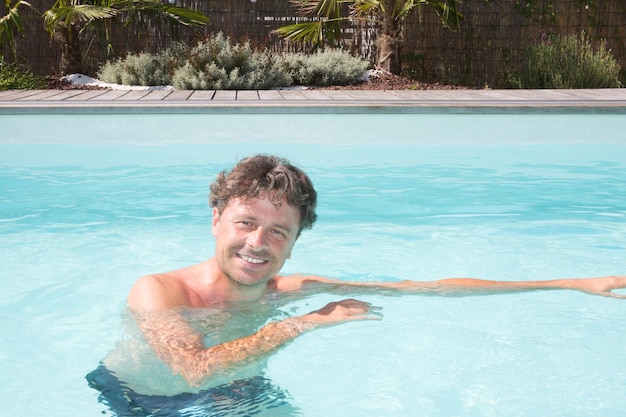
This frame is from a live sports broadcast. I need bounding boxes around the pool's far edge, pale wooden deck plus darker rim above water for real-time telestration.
[0,89,626,114]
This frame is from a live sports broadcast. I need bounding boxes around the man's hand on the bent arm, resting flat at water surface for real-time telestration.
[300,299,382,326]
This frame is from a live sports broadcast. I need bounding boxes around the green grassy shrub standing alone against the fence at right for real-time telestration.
[512,34,621,88]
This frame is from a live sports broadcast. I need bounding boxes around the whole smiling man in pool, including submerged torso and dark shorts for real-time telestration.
[83,157,626,415]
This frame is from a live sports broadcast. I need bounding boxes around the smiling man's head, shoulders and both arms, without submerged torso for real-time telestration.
[128,156,626,385]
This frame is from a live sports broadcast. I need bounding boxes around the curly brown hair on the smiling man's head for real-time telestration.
[209,155,317,236]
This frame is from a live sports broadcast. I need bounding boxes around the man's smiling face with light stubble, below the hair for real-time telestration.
[212,196,300,286]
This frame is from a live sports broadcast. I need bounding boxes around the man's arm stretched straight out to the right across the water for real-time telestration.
[276,275,626,299]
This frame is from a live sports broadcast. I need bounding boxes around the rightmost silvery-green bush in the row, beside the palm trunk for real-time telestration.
[283,49,369,86]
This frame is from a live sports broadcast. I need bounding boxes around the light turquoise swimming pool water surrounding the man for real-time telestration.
[0,110,626,417]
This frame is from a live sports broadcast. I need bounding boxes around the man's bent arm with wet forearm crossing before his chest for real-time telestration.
[129,276,375,385]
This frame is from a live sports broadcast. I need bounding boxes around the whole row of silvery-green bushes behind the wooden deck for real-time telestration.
[98,33,368,90]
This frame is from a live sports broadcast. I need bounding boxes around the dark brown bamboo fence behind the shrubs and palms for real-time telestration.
[0,0,626,87]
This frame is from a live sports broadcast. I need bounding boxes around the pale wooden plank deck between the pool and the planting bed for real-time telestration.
[0,89,626,112]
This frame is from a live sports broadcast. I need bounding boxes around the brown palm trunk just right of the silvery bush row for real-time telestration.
[376,0,402,75]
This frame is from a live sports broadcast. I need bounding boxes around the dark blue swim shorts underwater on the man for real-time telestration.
[86,365,301,417]
